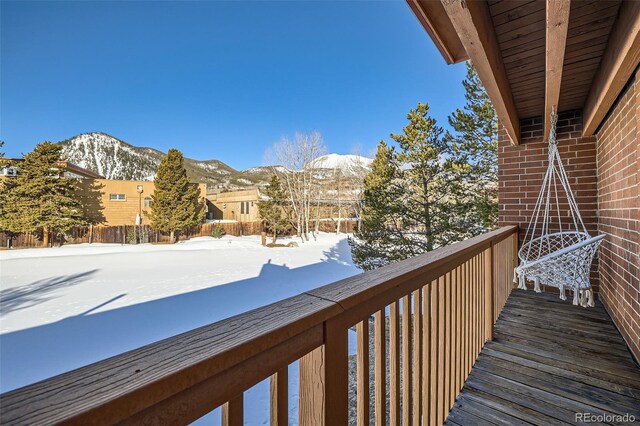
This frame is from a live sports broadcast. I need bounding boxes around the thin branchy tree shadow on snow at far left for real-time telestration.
[0,269,98,317]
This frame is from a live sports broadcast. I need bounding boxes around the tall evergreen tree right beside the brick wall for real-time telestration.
[449,62,498,231]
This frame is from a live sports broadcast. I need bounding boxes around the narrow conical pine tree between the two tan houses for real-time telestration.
[149,148,204,243]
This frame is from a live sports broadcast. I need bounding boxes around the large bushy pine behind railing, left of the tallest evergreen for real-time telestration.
[351,103,468,269]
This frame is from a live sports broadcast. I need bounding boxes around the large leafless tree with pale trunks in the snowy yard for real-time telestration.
[273,132,325,242]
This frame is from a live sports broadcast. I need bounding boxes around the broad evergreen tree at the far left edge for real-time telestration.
[0,142,89,246]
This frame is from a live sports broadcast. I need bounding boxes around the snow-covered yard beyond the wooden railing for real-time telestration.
[0,234,360,424]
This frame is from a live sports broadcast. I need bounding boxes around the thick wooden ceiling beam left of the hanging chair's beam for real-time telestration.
[442,0,520,144]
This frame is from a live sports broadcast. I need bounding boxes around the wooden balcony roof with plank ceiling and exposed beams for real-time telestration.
[407,0,640,143]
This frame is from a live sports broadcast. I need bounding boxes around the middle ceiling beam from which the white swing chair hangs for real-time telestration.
[544,0,571,140]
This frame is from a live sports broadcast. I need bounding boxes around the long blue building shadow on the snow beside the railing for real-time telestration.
[0,241,360,392]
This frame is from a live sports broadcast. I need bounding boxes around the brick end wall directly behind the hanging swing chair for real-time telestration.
[498,110,598,291]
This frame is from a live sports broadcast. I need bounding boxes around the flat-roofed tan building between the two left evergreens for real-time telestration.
[81,179,207,226]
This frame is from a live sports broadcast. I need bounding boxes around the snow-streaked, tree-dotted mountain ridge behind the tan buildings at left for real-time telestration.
[58,133,272,190]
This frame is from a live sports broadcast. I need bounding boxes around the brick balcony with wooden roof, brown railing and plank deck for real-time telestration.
[0,0,640,426]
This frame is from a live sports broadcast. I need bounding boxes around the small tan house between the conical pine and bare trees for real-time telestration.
[207,189,261,222]
